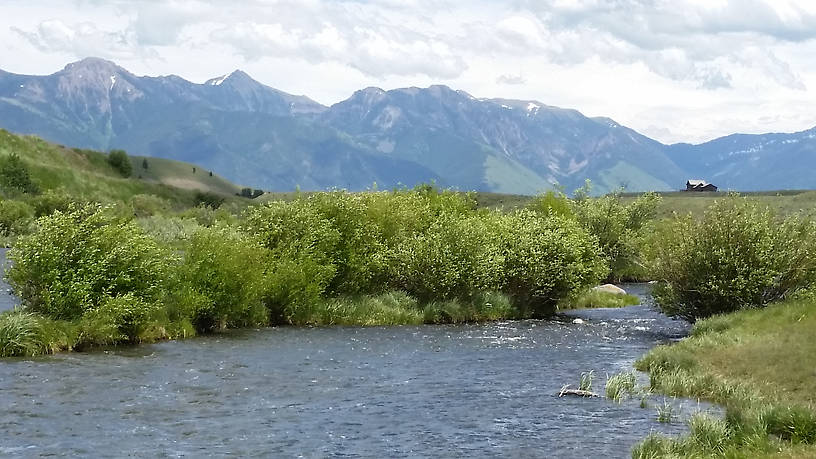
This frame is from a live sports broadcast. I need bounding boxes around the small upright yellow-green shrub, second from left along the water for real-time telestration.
[181,227,269,331]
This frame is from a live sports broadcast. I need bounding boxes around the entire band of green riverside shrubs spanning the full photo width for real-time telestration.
[0,187,816,353]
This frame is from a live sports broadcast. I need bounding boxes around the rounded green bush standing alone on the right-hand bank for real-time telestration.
[652,196,816,321]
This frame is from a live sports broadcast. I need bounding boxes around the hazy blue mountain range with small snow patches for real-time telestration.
[0,58,816,194]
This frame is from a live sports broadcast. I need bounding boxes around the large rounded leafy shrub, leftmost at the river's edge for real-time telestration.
[7,206,176,320]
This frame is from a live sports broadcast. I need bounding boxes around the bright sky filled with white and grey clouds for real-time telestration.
[0,0,816,143]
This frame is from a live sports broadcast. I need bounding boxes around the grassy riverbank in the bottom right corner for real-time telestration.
[633,295,816,458]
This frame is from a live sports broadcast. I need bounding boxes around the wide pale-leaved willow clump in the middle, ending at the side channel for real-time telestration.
[244,187,607,315]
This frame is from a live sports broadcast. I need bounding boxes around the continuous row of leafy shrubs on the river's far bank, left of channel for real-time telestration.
[0,187,608,355]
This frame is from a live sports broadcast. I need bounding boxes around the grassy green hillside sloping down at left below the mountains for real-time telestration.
[0,130,241,207]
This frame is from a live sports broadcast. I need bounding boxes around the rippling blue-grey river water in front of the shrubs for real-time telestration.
[0,285,700,458]
